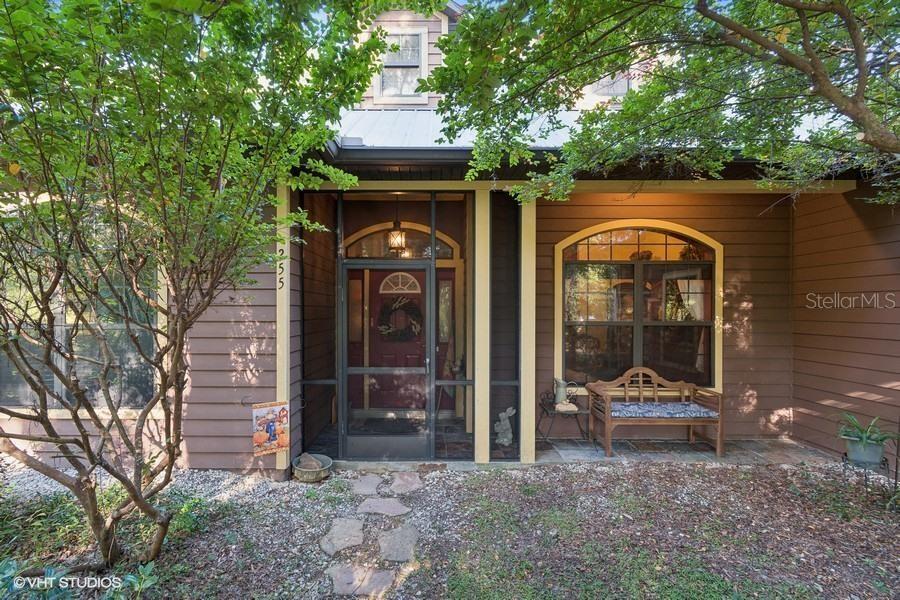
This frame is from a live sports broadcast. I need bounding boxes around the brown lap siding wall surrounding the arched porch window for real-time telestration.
[536,194,792,437]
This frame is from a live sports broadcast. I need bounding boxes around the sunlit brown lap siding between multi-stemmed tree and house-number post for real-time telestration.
[182,260,275,470]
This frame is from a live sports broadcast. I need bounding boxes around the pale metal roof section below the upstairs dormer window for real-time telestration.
[336,108,581,150]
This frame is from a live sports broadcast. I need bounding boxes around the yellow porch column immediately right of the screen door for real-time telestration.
[473,189,491,463]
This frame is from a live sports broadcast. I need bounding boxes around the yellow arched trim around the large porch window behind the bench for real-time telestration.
[553,219,725,394]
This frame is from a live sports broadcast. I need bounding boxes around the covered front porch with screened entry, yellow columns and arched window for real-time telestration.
[264,180,895,474]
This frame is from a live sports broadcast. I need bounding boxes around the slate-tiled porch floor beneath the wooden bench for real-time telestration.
[536,438,836,465]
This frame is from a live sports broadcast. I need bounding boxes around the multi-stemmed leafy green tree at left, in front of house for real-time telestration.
[0,0,408,567]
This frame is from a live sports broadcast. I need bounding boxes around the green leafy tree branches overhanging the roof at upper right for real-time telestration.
[425,0,900,203]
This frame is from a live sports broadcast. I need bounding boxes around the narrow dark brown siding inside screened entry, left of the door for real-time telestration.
[292,193,337,446]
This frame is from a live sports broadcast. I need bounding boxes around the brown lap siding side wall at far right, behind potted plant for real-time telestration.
[793,194,900,460]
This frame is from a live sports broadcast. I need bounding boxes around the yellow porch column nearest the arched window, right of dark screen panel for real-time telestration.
[519,202,537,463]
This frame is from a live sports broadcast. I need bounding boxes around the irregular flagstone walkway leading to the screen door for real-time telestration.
[319,472,423,597]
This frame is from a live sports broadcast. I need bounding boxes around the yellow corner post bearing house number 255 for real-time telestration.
[275,185,291,469]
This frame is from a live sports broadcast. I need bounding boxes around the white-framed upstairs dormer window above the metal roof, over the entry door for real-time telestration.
[375,28,428,104]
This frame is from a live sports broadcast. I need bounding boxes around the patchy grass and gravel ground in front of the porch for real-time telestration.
[0,463,900,600]
